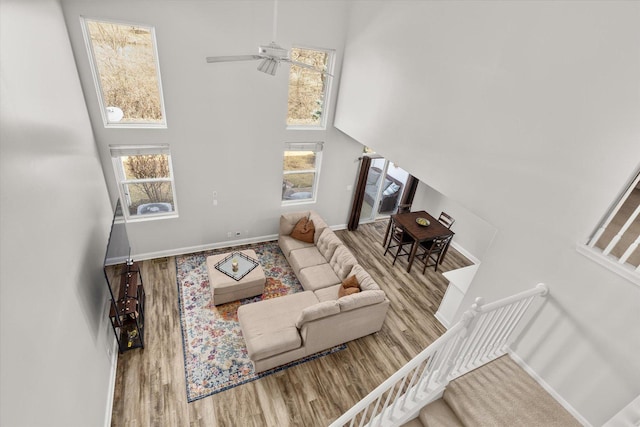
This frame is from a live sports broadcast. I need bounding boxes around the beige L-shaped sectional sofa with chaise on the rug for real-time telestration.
[238,211,389,372]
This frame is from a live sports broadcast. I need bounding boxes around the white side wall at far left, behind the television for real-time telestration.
[0,0,114,427]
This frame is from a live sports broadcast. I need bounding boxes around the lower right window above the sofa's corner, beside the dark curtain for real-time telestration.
[282,142,322,204]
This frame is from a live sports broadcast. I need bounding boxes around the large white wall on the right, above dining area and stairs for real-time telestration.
[336,1,640,425]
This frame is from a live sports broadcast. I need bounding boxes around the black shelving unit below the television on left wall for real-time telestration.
[109,262,145,353]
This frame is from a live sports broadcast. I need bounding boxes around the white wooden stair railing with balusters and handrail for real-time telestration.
[330,283,548,427]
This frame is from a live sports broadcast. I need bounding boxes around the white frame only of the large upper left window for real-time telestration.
[80,16,167,129]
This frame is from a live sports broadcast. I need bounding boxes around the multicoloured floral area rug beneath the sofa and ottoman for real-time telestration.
[176,242,346,402]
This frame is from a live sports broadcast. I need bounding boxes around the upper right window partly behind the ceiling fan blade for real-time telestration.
[287,47,333,128]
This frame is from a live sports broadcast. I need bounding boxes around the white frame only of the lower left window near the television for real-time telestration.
[109,144,179,222]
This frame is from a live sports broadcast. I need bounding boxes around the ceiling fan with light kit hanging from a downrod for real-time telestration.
[207,0,333,77]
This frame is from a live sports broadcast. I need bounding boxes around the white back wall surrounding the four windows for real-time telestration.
[63,0,362,258]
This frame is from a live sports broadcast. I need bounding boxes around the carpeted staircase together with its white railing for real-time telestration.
[331,283,579,427]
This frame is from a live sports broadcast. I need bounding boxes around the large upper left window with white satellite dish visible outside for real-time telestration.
[82,19,166,127]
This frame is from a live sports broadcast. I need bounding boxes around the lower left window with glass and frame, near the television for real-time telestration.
[110,145,178,220]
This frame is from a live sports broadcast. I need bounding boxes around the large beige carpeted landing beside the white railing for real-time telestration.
[442,355,580,427]
